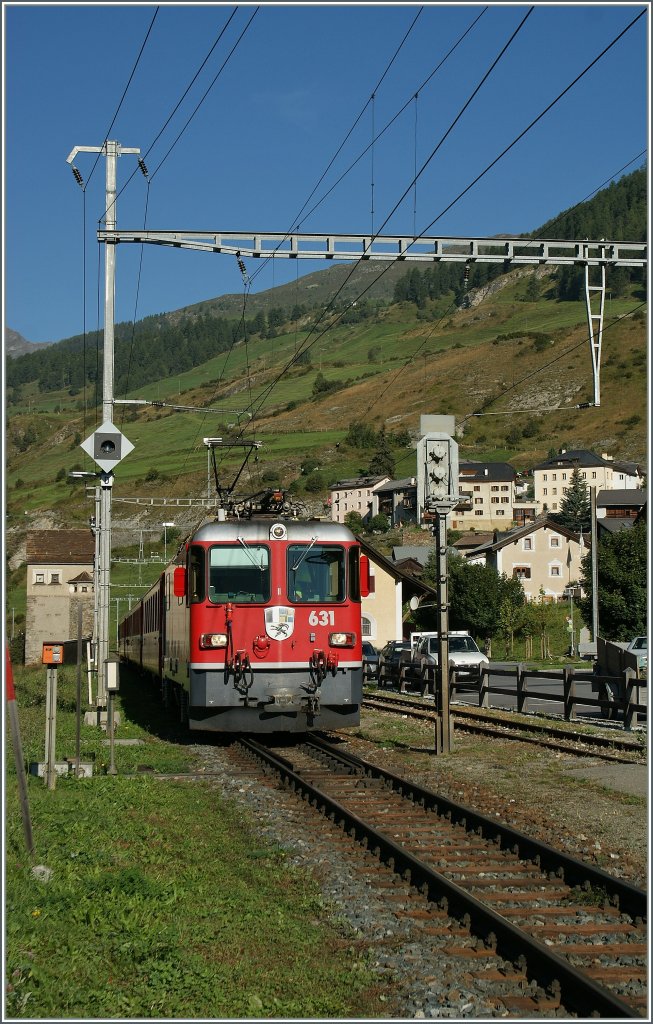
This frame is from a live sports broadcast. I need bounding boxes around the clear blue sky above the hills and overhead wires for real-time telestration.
[3,3,650,342]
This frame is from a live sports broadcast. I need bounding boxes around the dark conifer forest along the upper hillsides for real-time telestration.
[6,169,647,407]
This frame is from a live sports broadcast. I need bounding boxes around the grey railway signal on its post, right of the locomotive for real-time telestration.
[418,416,460,754]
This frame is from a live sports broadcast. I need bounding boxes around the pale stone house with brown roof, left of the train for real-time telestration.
[25,529,95,665]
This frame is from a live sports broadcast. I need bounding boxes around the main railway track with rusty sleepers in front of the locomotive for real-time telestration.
[223,737,647,1019]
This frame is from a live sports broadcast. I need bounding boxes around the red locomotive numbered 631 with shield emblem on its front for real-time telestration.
[119,497,369,733]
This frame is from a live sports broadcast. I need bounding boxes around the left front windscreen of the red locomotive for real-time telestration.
[209,544,270,604]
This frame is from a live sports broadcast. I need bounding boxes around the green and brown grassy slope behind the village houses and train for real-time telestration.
[6,281,648,630]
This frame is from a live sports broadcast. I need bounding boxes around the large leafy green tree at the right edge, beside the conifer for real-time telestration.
[578,522,648,640]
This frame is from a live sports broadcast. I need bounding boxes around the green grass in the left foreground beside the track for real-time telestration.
[5,669,383,1020]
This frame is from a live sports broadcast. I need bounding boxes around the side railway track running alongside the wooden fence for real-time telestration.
[362,693,647,764]
